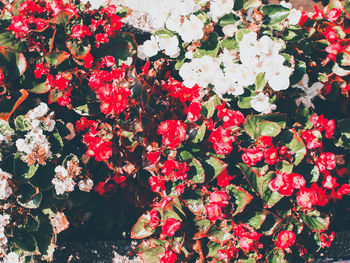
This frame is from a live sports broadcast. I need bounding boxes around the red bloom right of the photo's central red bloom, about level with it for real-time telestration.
[209,126,235,154]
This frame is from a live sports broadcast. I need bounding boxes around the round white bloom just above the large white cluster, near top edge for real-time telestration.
[179,15,204,42]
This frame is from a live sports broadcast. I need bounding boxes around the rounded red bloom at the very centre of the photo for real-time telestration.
[158,120,187,149]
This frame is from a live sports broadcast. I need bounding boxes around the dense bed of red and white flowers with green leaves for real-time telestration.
[0,0,350,263]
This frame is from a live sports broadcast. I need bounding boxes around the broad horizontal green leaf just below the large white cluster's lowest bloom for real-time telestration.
[244,113,286,139]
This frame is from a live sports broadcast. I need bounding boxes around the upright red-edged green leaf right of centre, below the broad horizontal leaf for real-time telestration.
[282,129,307,165]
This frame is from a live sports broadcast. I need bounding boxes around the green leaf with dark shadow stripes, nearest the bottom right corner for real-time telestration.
[300,210,330,232]
